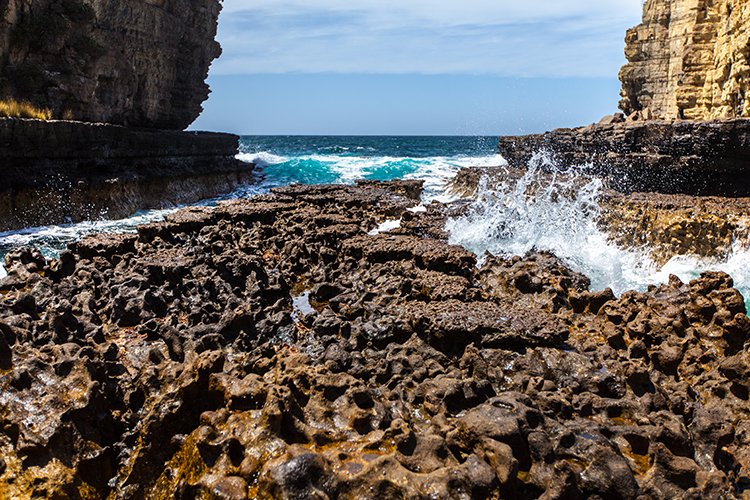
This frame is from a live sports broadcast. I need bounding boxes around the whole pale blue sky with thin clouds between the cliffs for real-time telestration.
[192,0,642,135]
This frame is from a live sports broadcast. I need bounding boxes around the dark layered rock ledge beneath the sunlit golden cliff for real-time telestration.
[499,119,750,197]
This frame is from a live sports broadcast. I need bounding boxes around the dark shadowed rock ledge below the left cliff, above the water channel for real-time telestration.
[0,119,253,230]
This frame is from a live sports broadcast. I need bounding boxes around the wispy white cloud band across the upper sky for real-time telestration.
[213,0,641,77]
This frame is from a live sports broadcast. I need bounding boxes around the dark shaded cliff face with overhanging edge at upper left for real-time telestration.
[0,0,221,129]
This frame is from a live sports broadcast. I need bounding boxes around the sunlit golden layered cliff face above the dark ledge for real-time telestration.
[620,0,750,120]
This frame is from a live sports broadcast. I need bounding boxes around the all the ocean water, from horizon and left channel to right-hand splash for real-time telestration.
[0,136,750,308]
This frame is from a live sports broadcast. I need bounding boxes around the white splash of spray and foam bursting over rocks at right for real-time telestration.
[446,154,750,297]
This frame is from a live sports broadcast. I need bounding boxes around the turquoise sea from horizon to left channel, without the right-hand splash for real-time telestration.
[0,136,502,276]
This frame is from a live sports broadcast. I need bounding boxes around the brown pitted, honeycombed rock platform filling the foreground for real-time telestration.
[0,182,750,499]
